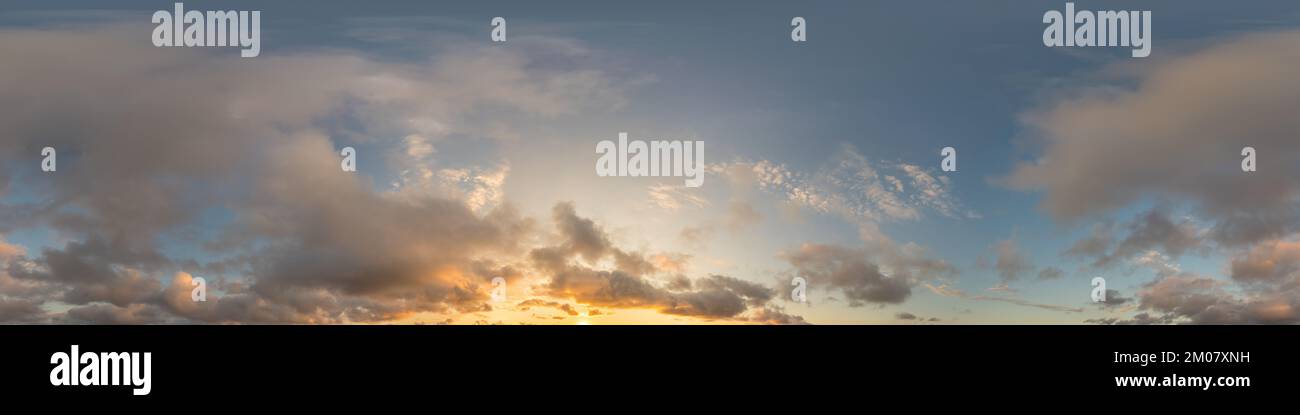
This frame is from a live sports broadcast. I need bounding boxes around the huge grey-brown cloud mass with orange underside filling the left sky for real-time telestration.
[0,25,634,323]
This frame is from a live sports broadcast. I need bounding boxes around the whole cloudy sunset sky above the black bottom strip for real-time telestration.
[0,1,1300,324]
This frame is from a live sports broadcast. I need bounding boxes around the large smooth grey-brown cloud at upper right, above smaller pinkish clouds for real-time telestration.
[1006,31,1300,248]
